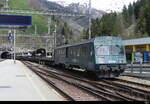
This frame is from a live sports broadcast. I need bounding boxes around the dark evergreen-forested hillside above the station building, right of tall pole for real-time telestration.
[86,0,150,39]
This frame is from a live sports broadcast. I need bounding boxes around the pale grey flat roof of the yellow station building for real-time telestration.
[123,37,150,46]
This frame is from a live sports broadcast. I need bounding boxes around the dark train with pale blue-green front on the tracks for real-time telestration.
[16,36,127,78]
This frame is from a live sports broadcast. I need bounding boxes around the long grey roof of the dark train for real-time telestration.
[55,36,121,49]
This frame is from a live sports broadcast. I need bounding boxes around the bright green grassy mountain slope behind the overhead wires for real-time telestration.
[9,0,48,34]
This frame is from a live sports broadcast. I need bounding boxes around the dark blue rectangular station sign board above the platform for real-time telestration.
[0,15,32,26]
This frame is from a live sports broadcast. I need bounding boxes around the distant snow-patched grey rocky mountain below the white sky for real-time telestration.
[37,0,105,28]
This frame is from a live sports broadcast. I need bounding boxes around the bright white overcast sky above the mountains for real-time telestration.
[49,0,137,11]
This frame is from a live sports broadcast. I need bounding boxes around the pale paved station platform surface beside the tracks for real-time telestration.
[0,60,65,101]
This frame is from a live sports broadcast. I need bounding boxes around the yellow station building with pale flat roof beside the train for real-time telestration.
[124,37,150,63]
